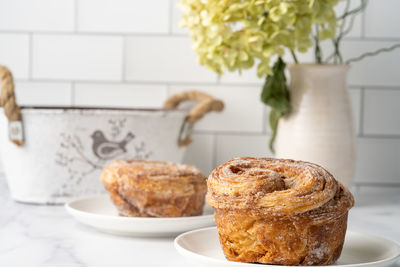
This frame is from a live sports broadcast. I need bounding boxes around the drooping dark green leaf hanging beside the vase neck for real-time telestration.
[261,57,291,152]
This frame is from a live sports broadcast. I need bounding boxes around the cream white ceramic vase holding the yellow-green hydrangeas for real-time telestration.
[275,64,355,186]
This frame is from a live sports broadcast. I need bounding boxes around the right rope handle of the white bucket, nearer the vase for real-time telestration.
[164,90,224,146]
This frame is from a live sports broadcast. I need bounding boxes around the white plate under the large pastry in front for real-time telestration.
[175,227,400,267]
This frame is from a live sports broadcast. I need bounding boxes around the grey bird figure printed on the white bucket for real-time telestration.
[91,130,135,160]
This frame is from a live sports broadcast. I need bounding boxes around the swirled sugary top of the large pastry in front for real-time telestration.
[207,157,354,220]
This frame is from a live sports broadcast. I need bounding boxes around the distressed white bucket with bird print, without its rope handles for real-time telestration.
[0,108,187,203]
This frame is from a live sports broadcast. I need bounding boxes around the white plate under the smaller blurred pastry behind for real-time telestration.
[65,195,215,236]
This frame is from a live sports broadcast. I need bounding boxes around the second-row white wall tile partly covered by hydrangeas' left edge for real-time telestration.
[125,37,217,83]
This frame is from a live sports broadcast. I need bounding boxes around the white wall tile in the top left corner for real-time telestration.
[0,0,75,32]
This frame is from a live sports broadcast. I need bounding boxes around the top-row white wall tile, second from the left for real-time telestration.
[77,0,169,33]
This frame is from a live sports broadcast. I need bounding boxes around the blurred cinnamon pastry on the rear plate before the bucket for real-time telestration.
[101,160,207,217]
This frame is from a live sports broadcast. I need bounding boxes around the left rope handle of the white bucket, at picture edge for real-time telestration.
[0,66,24,146]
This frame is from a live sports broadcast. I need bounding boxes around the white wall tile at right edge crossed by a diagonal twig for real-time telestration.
[342,40,400,86]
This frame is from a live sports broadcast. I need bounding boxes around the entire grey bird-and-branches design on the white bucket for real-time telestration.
[55,118,154,196]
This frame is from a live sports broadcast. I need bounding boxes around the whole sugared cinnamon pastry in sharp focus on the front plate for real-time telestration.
[207,157,354,265]
